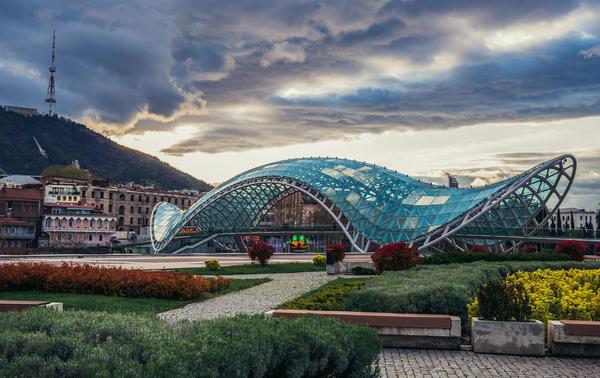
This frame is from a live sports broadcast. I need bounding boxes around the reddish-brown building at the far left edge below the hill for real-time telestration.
[0,175,43,253]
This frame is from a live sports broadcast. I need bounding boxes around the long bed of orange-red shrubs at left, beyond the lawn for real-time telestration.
[0,263,230,299]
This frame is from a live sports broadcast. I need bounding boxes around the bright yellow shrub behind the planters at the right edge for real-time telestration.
[469,269,600,323]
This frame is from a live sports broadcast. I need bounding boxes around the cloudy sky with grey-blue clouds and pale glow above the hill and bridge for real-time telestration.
[0,0,600,208]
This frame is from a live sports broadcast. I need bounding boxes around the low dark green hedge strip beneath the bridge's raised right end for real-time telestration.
[421,251,570,265]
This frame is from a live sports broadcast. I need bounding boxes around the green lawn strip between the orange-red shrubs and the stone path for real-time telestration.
[0,278,269,315]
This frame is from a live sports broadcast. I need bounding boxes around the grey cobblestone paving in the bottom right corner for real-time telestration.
[379,349,600,378]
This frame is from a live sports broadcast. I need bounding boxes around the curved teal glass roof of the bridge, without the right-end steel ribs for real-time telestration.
[153,158,572,252]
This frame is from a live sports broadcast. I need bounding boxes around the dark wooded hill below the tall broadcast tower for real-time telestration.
[0,108,210,190]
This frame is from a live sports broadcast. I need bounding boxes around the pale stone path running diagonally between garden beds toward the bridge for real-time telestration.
[158,272,335,323]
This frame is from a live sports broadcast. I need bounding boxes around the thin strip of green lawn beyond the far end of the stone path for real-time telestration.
[176,263,325,276]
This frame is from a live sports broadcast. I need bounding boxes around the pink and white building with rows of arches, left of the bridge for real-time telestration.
[42,202,117,248]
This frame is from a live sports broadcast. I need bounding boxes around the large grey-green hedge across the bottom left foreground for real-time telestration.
[0,310,381,377]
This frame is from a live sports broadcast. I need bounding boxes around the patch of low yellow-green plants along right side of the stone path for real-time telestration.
[281,278,369,311]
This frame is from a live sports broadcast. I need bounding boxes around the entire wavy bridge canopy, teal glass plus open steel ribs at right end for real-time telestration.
[151,155,576,252]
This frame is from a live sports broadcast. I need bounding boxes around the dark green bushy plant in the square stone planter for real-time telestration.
[476,278,531,322]
